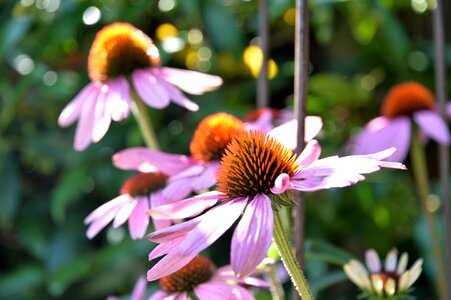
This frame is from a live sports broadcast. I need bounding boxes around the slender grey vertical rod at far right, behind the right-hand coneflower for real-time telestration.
[432,0,451,299]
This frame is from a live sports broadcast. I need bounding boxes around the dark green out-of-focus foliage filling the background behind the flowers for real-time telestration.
[0,0,451,299]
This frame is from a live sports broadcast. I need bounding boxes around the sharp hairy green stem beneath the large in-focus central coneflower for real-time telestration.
[273,211,313,300]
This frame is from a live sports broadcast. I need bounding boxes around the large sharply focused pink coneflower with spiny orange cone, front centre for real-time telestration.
[147,131,405,280]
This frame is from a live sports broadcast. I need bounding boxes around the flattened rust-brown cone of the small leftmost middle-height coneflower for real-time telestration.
[120,172,168,197]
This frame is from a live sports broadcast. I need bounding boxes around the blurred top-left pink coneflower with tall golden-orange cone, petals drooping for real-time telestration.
[58,23,222,151]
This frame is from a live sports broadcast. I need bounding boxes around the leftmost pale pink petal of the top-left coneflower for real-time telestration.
[58,82,97,127]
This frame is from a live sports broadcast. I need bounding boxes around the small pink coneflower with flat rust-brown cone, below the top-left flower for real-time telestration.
[84,172,178,239]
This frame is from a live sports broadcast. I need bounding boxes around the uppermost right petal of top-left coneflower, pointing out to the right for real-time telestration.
[158,67,222,95]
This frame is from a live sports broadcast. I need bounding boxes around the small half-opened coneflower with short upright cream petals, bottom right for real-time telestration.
[343,249,423,299]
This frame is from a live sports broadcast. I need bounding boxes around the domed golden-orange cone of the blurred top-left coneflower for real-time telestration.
[88,22,160,81]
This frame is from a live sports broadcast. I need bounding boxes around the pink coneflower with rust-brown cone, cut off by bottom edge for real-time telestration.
[149,256,269,300]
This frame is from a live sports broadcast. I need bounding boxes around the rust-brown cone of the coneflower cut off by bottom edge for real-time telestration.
[159,256,214,293]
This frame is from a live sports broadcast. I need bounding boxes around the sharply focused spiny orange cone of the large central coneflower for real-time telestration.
[216,131,300,200]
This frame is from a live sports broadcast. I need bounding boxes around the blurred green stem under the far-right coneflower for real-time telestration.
[410,127,446,300]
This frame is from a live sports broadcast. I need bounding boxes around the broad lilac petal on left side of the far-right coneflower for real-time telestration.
[353,117,411,162]
